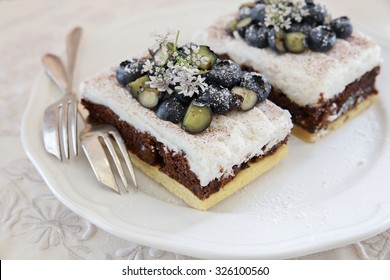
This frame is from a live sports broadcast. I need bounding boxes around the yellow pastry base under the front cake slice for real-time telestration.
[130,144,288,210]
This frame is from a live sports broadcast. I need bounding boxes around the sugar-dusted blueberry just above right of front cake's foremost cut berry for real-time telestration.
[199,85,233,114]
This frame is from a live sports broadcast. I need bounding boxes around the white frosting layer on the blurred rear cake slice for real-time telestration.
[194,15,382,106]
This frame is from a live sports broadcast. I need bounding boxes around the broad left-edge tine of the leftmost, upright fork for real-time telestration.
[43,104,62,161]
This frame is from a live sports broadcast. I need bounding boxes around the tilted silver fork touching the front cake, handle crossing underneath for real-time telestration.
[44,55,138,193]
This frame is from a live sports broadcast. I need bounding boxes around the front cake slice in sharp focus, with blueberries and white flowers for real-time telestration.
[80,34,292,210]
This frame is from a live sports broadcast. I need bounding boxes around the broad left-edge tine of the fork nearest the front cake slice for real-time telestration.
[81,135,120,193]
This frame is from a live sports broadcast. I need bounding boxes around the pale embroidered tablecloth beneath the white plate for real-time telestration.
[0,0,390,259]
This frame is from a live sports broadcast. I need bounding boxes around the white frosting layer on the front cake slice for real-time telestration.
[80,67,292,186]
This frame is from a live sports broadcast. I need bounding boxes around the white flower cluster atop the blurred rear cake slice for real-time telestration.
[264,0,307,31]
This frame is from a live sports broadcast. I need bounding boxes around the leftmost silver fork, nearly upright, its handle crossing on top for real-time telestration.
[42,27,82,161]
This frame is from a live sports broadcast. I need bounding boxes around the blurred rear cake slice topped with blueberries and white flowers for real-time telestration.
[195,0,382,142]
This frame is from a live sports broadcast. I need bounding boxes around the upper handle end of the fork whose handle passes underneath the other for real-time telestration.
[42,54,71,94]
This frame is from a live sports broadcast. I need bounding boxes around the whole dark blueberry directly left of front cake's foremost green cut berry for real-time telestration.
[156,97,186,123]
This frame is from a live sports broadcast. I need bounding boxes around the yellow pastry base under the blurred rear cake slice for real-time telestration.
[292,94,377,143]
